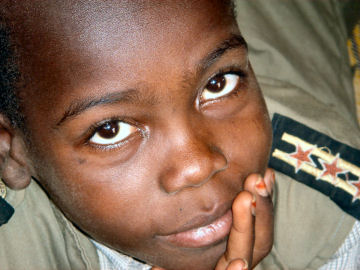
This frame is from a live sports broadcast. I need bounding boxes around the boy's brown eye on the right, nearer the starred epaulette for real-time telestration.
[201,73,240,101]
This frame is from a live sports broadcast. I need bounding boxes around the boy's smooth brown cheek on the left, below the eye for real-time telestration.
[32,151,157,247]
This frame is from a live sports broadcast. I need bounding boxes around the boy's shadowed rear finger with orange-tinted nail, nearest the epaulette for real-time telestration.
[244,169,274,267]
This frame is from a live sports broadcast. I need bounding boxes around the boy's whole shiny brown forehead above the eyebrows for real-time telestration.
[7,0,237,121]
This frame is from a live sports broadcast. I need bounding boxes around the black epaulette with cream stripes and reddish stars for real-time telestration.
[269,114,360,219]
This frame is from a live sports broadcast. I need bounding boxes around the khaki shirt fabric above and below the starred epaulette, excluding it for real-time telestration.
[235,0,360,269]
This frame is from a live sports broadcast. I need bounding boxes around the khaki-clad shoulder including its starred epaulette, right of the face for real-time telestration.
[235,0,360,269]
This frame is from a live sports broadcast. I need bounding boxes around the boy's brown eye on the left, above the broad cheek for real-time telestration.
[89,120,138,145]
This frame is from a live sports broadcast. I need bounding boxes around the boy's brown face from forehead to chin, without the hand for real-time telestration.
[12,1,271,269]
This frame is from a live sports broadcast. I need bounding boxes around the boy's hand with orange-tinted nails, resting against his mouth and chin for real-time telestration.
[152,169,275,270]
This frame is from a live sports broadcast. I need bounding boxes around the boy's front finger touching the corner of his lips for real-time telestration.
[216,191,254,270]
